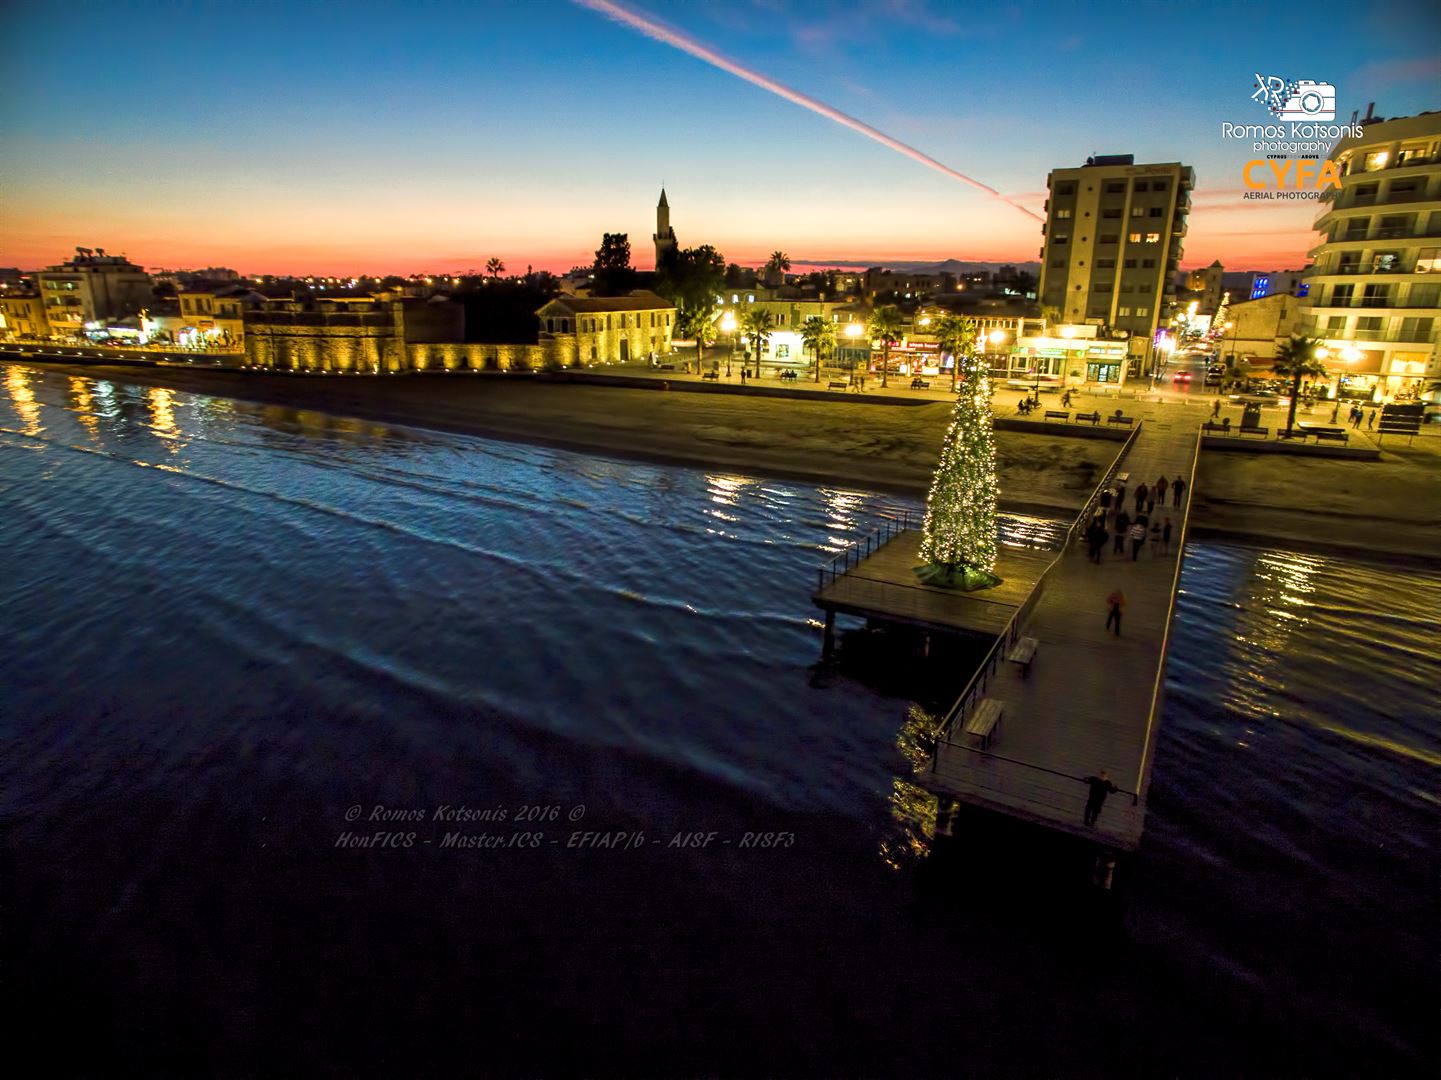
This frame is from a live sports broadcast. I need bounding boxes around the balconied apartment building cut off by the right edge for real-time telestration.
[1303,112,1441,399]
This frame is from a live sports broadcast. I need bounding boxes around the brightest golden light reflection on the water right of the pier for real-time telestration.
[1225,551,1326,720]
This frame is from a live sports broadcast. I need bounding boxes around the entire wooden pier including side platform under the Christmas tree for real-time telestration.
[816,420,1200,851]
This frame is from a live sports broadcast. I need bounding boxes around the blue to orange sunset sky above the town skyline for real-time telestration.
[0,0,1441,274]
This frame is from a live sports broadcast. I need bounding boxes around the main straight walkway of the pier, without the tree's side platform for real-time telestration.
[922,409,1199,849]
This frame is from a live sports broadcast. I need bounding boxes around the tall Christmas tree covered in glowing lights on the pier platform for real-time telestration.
[915,355,1000,591]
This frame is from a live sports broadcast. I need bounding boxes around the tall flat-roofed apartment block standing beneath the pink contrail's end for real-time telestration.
[1039,154,1196,382]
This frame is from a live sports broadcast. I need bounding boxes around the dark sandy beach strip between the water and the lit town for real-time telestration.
[4,358,1441,567]
